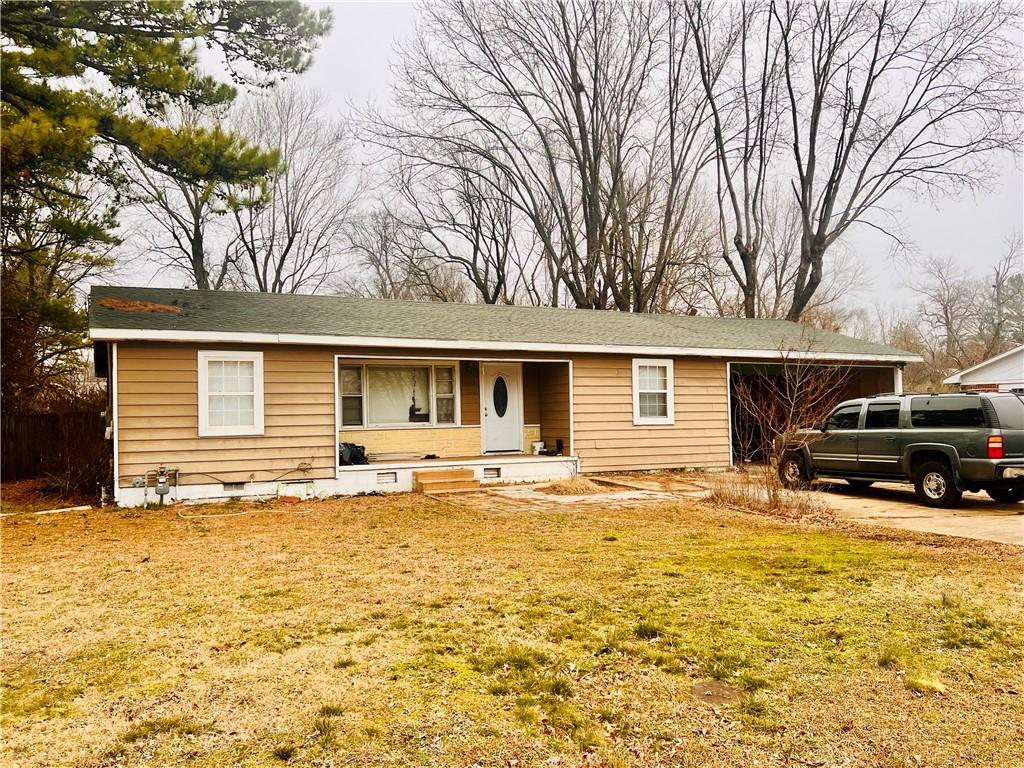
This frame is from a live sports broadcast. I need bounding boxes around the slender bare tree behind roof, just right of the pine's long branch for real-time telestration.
[228,85,356,293]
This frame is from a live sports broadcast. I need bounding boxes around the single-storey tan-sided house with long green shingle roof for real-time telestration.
[89,287,918,505]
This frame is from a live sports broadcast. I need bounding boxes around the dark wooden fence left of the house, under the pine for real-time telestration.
[0,411,111,492]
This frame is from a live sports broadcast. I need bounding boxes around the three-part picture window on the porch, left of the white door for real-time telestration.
[338,361,458,427]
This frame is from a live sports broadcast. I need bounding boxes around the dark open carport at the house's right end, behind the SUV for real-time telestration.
[729,360,903,464]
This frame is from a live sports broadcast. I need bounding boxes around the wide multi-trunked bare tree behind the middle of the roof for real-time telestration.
[373,0,710,310]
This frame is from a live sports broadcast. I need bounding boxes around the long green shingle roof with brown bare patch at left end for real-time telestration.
[89,286,920,362]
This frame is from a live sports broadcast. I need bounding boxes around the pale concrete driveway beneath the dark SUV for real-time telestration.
[817,482,1024,547]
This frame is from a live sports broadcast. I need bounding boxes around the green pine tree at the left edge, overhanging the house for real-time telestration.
[0,0,331,409]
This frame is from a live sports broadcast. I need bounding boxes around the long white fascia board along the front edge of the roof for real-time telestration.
[90,328,923,362]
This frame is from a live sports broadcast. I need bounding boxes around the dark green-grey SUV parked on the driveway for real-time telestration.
[778,392,1024,507]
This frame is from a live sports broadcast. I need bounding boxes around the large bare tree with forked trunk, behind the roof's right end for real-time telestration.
[771,0,1021,319]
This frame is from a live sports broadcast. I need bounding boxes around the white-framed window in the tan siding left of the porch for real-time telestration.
[199,349,263,437]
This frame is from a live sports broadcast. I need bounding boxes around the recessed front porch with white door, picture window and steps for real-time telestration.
[336,355,579,493]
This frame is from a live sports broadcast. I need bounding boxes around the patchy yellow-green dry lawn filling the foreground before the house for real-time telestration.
[0,496,1024,768]
